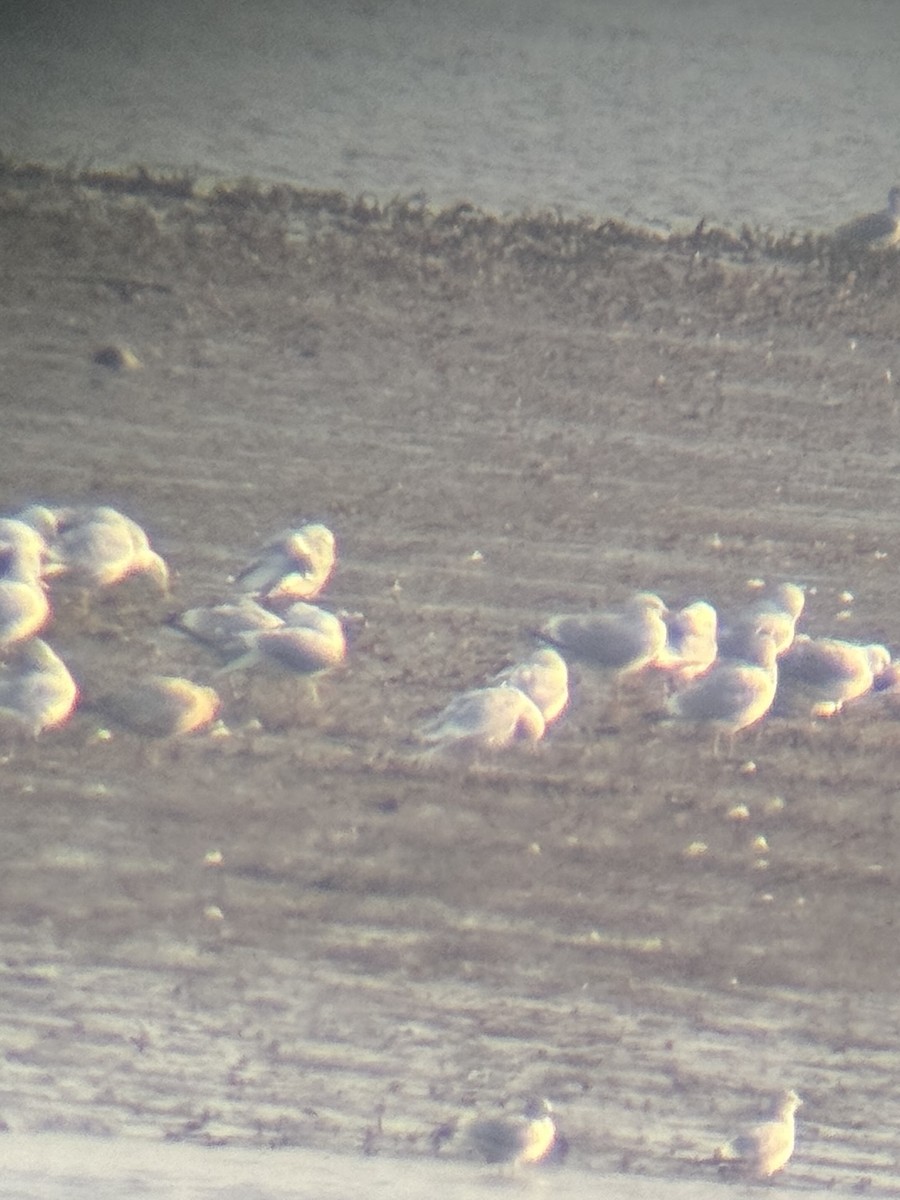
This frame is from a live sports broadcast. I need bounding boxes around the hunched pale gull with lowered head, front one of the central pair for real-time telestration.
[418,684,546,751]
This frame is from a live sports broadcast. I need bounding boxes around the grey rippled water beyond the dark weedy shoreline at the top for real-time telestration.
[0,0,900,228]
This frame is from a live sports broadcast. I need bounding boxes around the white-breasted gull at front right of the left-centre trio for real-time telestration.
[220,601,347,674]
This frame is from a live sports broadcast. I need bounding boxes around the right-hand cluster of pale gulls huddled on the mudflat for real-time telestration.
[420,583,900,752]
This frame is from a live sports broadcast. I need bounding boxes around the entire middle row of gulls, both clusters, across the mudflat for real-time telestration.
[0,505,900,756]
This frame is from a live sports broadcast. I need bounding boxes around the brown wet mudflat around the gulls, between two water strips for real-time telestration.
[0,166,900,1195]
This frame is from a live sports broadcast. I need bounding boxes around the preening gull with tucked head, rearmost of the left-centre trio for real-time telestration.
[235,524,336,606]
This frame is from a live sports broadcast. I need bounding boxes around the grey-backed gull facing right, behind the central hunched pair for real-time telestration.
[539,592,667,678]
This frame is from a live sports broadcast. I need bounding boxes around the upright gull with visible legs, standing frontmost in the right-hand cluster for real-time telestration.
[666,628,778,754]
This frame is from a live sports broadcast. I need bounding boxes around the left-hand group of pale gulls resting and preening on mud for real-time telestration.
[0,504,347,736]
